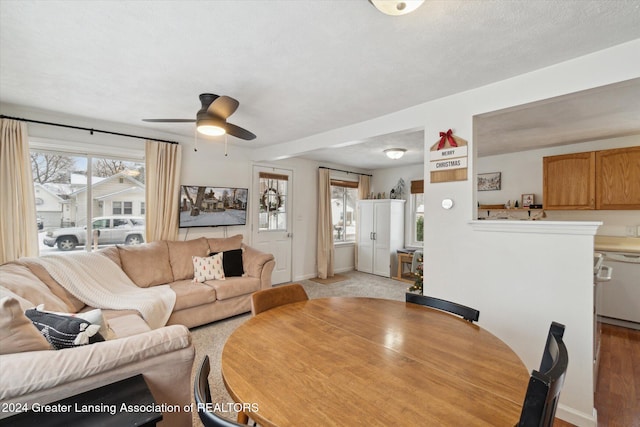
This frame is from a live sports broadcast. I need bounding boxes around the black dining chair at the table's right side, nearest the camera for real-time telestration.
[516,322,569,427]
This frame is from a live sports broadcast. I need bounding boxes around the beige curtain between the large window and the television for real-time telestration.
[145,141,182,242]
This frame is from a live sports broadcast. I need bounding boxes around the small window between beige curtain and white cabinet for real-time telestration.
[331,179,358,242]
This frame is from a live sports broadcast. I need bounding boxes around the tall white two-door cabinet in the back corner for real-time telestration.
[357,199,404,277]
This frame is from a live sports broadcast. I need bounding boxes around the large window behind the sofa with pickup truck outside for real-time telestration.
[30,150,145,253]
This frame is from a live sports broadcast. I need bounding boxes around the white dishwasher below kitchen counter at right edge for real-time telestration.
[596,251,640,329]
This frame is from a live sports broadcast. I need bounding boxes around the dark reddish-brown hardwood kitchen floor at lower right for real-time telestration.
[554,324,640,427]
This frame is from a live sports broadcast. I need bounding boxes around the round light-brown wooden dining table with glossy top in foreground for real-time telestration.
[221,297,529,427]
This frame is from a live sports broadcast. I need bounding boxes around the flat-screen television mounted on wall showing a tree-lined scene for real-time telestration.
[180,185,249,228]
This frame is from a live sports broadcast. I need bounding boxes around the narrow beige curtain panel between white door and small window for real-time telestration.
[317,169,335,279]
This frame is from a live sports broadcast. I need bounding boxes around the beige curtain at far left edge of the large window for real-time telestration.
[0,119,38,264]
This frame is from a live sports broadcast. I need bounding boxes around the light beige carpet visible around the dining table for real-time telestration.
[191,271,410,427]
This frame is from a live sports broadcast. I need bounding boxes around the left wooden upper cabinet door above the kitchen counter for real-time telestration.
[542,151,596,210]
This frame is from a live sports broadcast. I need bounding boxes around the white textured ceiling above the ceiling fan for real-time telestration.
[0,0,640,168]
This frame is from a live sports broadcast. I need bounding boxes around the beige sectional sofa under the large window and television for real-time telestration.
[0,235,275,426]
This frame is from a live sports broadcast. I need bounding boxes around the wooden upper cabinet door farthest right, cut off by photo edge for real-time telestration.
[596,147,640,209]
